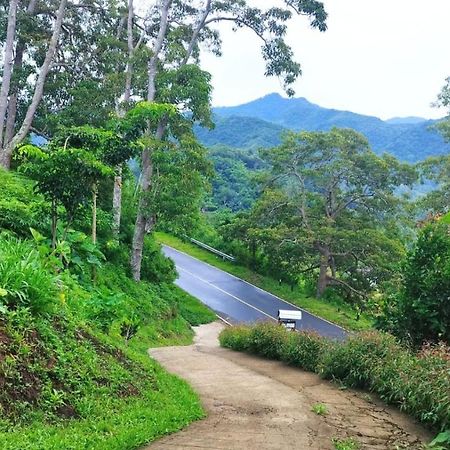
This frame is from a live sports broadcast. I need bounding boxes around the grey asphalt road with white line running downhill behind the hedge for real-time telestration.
[163,245,347,339]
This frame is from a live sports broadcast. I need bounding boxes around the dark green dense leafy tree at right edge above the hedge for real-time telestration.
[378,220,450,346]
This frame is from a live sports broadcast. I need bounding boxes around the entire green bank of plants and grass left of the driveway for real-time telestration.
[0,169,216,450]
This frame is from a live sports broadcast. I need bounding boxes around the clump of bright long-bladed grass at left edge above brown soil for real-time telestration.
[0,234,58,313]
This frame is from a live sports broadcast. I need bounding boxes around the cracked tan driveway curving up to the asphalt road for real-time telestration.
[147,323,432,450]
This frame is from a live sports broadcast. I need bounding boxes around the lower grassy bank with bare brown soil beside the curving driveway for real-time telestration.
[0,316,204,450]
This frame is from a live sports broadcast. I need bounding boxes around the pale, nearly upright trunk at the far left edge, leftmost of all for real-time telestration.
[0,0,19,151]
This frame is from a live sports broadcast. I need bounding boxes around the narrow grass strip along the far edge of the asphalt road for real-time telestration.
[155,232,373,331]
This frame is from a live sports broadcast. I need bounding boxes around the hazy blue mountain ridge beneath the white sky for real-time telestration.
[197,94,450,162]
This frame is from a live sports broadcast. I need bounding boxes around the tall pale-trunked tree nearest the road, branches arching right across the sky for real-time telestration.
[131,0,326,280]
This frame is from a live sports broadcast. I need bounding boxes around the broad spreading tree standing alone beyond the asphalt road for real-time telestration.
[251,128,416,298]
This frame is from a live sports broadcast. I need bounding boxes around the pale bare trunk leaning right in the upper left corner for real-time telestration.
[0,0,67,168]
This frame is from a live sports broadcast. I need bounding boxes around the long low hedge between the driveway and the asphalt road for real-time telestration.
[219,323,450,430]
